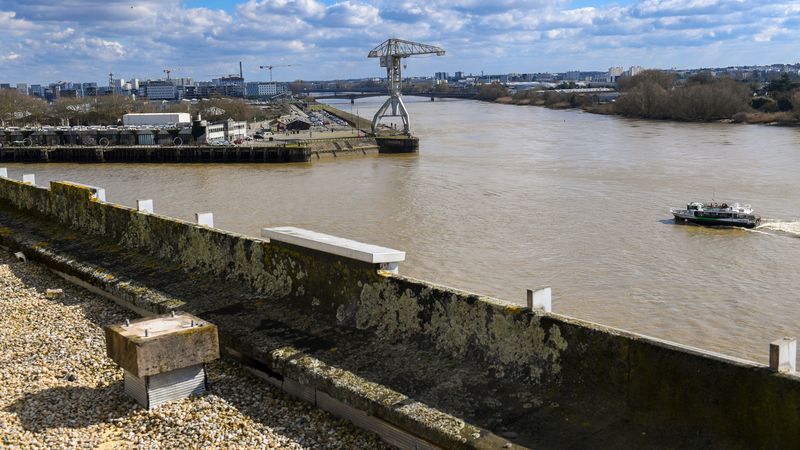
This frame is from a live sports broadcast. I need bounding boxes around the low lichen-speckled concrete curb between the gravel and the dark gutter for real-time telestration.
[0,234,500,450]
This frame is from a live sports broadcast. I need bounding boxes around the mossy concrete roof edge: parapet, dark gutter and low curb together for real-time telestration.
[0,175,800,448]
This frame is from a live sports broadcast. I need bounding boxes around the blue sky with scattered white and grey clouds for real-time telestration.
[0,0,800,83]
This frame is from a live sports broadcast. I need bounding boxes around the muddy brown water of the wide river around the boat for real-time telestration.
[5,98,800,362]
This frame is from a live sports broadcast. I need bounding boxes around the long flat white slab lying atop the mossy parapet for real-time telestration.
[261,227,406,266]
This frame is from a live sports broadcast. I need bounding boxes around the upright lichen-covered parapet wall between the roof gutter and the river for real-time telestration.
[0,177,800,448]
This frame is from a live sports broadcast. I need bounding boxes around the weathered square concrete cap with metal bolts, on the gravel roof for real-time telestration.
[105,313,219,378]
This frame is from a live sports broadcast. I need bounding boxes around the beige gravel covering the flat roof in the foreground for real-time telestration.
[0,250,390,449]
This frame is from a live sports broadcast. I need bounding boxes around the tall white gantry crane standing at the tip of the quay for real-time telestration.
[367,39,444,135]
